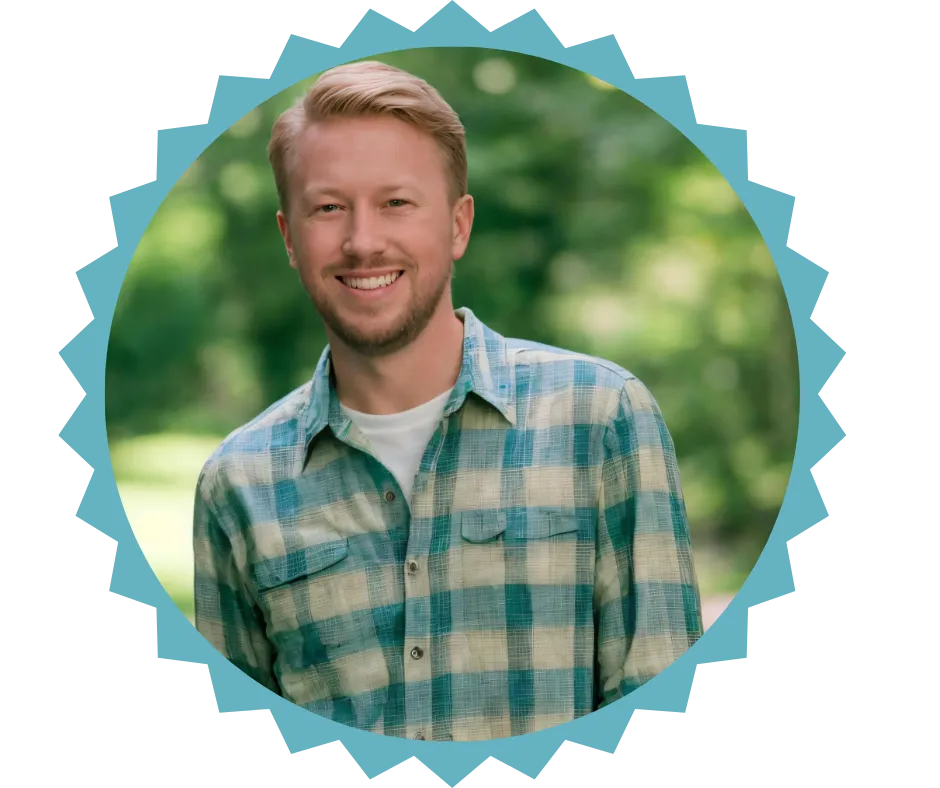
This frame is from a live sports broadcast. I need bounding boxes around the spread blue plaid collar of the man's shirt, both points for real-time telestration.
[301,307,516,458]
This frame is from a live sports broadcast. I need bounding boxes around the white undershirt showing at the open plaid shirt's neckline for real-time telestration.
[341,391,450,507]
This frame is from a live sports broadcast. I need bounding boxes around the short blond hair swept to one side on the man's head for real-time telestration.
[268,61,467,214]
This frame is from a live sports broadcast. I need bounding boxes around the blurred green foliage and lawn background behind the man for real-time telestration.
[106,48,799,624]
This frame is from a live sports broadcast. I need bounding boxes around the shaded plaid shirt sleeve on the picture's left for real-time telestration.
[193,470,281,695]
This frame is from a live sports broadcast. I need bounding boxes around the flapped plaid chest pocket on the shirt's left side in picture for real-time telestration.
[254,535,389,705]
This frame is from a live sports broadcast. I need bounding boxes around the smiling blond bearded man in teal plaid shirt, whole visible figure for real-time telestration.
[194,58,702,741]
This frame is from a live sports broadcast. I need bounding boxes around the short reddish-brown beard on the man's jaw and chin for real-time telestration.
[307,261,453,358]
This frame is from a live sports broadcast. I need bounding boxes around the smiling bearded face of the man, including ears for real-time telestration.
[278,117,473,356]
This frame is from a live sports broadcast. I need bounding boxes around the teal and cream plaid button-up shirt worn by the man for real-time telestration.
[194,309,702,741]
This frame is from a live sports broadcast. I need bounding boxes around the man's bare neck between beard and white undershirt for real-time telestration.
[330,299,464,415]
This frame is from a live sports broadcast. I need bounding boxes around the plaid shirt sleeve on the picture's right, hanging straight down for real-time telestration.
[594,378,703,708]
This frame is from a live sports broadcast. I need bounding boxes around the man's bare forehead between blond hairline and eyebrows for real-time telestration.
[295,116,444,186]
